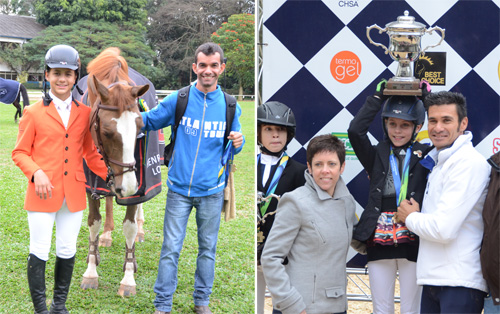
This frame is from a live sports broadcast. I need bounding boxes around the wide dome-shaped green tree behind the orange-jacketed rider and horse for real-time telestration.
[23,21,156,77]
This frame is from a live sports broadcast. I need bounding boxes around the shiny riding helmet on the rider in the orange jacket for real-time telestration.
[43,45,83,102]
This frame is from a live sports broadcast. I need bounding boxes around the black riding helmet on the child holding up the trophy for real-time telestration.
[382,96,425,142]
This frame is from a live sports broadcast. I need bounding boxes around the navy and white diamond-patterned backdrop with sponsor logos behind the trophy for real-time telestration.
[262,0,500,260]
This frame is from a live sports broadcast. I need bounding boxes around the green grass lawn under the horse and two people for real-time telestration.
[0,101,255,314]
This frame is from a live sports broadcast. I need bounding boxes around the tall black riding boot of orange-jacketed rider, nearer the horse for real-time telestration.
[50,256,75,314]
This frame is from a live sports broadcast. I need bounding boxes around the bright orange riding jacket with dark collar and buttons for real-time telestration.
[12,100,107,212]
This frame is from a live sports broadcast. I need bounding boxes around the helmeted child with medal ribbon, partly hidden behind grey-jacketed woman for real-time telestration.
[257,101,306,314]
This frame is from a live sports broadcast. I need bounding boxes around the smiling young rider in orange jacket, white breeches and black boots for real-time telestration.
[12,45,107,314]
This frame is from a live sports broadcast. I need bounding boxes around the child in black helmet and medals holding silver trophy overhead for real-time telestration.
[348,80,430,314]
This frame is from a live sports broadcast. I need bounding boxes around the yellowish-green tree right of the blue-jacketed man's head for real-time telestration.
[212,14,255,95]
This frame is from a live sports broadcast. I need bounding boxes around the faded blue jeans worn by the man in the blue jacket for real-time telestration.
[154,190,224,312]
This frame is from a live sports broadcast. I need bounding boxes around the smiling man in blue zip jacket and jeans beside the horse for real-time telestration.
[142,43,245,314]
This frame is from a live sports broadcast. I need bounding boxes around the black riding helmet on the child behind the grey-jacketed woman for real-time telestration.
[257,101,296,147]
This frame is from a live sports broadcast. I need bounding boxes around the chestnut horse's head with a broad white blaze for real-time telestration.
[88,76,149,197]
